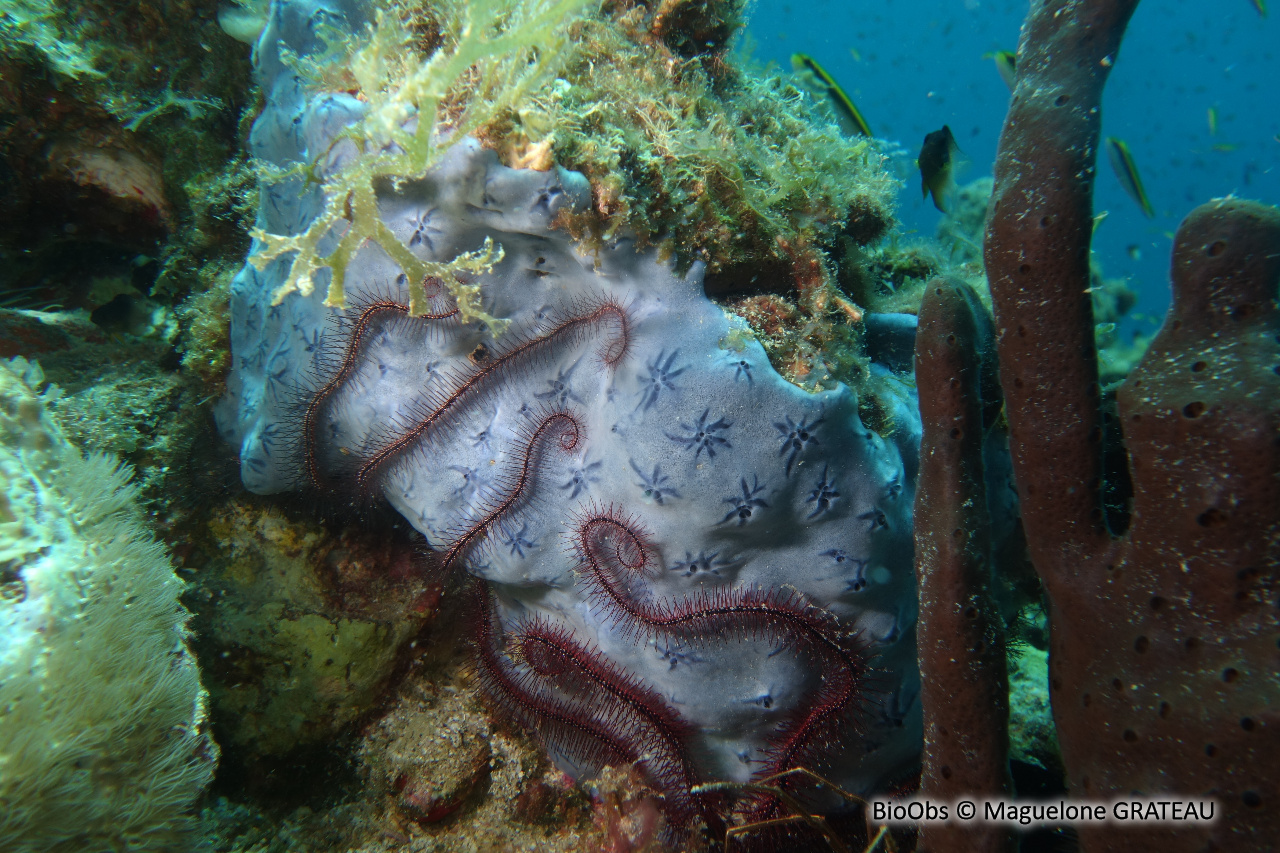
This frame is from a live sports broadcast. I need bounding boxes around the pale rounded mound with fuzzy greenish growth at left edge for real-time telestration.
[0,359,218,853]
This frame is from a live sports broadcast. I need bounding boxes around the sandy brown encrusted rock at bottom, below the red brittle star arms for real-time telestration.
[201,645,606,853]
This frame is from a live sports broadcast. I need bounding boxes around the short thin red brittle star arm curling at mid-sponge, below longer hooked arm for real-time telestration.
[443,410,582,569]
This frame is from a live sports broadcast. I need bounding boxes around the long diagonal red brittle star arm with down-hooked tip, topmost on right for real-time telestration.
[356,298,631,494]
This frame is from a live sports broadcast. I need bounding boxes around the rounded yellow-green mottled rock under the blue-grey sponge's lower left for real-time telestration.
[187,502,440,763]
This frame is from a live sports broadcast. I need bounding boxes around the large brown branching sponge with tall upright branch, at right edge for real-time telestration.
[986,0,1280,853]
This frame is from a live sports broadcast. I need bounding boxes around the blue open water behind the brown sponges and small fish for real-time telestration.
[748,0,1280,329]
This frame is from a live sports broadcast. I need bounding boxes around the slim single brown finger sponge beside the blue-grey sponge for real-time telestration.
[915,279,1012,853]
